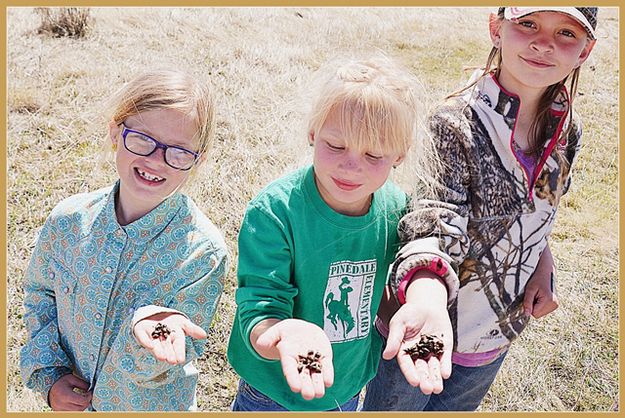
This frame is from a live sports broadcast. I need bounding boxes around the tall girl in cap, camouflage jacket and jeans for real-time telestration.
[364,7,597,410]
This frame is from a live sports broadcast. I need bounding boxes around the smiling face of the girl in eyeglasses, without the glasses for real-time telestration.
[109,109,197,225]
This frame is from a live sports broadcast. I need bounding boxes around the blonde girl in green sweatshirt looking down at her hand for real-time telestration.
[228,56,418,411]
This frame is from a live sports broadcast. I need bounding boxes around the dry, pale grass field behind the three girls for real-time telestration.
[6,8,619,411]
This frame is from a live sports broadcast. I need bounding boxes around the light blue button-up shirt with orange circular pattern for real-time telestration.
[20,183,227,411]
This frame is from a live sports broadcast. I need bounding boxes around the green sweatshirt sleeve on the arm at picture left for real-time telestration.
[236,205,297,357]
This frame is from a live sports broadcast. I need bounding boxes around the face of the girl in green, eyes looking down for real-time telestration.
[310,110,403,216]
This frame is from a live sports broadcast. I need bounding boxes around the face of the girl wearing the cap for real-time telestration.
[490,12,595,94]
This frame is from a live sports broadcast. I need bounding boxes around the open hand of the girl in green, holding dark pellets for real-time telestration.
[256,319,334,400]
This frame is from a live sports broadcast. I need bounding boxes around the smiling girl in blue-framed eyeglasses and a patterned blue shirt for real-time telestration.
[20,70,228,411]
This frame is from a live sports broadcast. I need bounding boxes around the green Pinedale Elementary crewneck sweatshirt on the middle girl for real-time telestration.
[228,167,407,411]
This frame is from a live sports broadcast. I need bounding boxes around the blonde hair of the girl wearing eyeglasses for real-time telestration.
[109,69,215,160]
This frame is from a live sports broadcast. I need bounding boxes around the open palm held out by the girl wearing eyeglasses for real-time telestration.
[134,312,207,364]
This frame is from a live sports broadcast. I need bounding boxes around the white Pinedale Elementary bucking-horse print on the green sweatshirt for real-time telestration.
[323,260,376,342]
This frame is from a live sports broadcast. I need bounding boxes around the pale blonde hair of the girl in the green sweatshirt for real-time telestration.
[308,54,418,155]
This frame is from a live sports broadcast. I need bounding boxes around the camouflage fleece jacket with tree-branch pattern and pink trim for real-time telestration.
[391,71,581,353]
